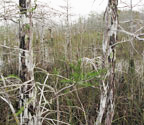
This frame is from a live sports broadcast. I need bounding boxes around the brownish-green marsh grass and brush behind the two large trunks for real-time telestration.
[0,10,144,125]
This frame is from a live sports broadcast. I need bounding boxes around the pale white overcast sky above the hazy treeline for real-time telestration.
[39,0,144,16]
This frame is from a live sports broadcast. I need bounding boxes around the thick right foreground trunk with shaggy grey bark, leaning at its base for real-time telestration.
[95,0,118,125]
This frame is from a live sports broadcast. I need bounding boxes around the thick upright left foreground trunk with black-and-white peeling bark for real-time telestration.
[19,0,41,125]
